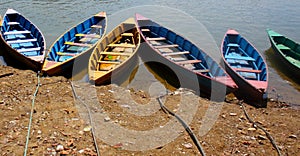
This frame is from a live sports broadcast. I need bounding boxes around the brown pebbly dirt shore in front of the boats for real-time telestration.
[0,66,300,156]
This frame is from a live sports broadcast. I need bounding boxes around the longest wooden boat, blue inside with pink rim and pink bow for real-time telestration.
[136,14,236,100]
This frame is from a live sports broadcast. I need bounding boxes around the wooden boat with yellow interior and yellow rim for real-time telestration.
[88,18,140,85]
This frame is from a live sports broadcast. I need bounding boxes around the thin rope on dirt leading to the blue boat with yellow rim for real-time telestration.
[69,80,100,156]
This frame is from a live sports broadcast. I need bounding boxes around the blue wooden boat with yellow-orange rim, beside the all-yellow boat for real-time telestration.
[42,12,107,76]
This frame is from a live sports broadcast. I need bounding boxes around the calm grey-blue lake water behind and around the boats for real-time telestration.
[0,0,300,106]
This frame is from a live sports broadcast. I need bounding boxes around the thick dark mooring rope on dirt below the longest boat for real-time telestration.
[157,95,205,156]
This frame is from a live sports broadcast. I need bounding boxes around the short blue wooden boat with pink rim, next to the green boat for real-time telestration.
[221,29,268,107]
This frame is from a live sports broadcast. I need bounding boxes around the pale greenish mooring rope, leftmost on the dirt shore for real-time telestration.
[24,72,41,156]
